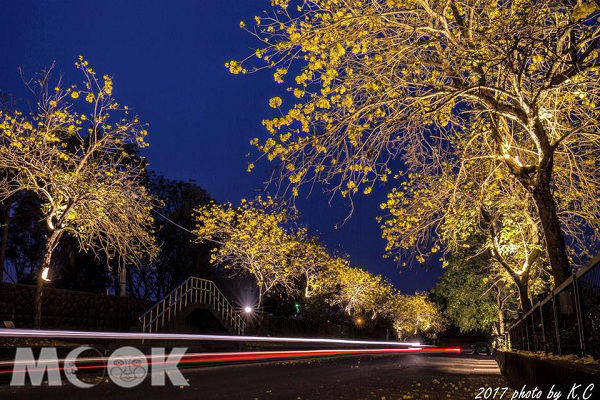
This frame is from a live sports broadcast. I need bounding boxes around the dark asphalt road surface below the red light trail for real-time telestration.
[0,354,510,400]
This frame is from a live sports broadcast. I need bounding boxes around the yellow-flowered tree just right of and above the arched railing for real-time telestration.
[194,197,300,307]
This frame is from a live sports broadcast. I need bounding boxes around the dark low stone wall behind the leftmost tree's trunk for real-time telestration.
[0,283,153,332]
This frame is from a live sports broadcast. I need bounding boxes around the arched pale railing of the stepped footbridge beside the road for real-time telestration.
[139,276,246,335]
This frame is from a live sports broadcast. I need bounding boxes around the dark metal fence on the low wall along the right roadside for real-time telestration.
[508,255,600,357]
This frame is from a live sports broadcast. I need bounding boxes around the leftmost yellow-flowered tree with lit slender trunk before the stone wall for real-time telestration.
[0,57,157,327]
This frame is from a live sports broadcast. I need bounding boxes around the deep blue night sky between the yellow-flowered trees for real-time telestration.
[0,0,439,293]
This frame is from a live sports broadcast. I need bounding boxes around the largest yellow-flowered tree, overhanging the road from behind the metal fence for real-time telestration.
[232,0,600,284]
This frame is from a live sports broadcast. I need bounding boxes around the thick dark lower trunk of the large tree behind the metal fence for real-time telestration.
[531,177,571,286]
